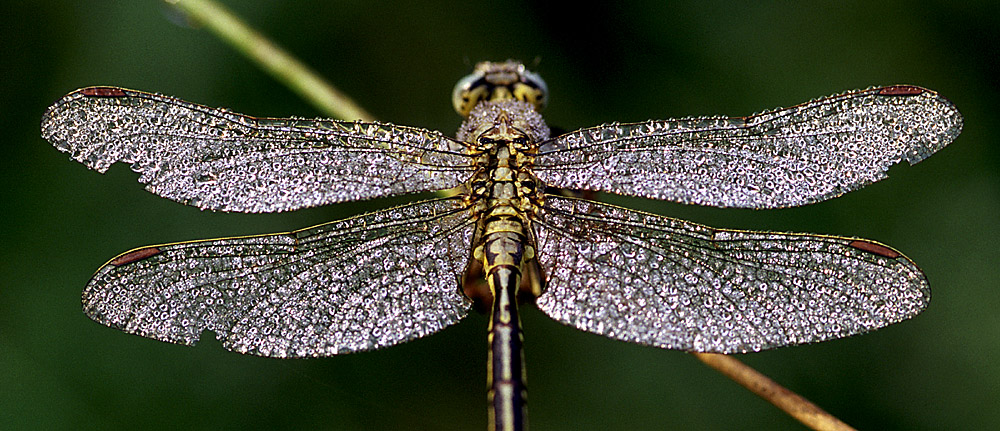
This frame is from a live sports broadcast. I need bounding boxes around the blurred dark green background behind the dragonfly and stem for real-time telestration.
[0,0,1000,430]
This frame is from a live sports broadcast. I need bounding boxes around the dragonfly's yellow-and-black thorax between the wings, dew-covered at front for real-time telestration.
[457,100,548,311]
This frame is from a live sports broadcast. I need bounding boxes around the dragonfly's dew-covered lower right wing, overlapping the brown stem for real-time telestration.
[534,196,930,353]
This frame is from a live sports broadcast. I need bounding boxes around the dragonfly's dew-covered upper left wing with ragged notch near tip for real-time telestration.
[42,87,472,212]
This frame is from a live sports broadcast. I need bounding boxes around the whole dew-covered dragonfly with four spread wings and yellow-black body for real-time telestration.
[41,60,962,430]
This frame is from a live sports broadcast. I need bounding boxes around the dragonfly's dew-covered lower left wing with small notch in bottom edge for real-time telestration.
[83,199,475,357]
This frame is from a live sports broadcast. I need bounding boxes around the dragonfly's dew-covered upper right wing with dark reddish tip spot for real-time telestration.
[535,86,962,208]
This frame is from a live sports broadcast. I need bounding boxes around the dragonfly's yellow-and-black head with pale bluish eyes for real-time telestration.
[451,60,549,117]
